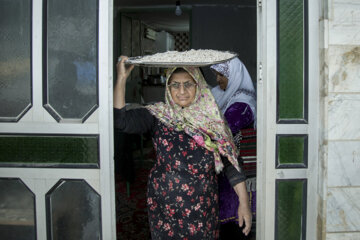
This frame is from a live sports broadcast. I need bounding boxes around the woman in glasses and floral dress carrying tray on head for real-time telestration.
[114,56,251,239]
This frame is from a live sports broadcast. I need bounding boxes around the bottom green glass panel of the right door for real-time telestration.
[275,179,307,240]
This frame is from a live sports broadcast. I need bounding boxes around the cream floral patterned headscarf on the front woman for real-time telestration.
[146,67,240,173]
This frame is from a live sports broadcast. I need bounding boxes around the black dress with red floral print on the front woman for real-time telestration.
[114,108,245,240]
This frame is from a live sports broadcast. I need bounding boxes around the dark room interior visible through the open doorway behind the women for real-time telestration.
[114,0,257,239]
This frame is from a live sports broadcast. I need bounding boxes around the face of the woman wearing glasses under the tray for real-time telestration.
[168,72,196,107]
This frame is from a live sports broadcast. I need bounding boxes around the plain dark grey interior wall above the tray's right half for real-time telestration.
[190,4,257,86]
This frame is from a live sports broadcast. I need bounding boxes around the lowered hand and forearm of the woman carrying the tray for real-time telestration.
[234,181,252,236]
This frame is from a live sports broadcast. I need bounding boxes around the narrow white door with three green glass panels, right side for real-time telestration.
[257,0,319,240]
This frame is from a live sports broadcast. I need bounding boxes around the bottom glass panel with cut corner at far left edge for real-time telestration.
[0,178,36,240]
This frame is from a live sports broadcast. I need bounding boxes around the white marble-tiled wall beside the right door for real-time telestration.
[318,0,360,240]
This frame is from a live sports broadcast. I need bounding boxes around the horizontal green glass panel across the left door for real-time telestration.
[0,135,99,167]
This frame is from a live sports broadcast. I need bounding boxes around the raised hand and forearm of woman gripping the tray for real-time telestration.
[114,56,134,109]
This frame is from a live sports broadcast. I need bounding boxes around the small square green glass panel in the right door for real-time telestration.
[276,135,307,168]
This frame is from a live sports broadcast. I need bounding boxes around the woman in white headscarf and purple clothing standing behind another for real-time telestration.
[210,58,256,239]
